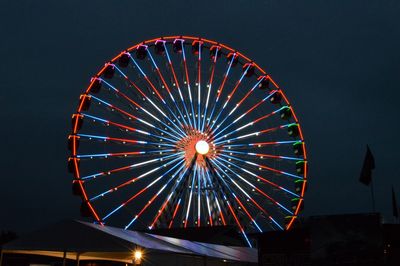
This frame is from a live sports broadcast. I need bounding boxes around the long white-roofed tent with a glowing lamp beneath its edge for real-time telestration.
[0,221,258,266]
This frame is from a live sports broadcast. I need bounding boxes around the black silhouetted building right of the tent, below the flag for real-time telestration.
[258,213,400,266]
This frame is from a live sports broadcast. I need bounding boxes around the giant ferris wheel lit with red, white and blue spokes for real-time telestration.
[68,36,307,246]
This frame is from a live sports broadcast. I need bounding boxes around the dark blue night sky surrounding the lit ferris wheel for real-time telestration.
[0,0,400,232]
